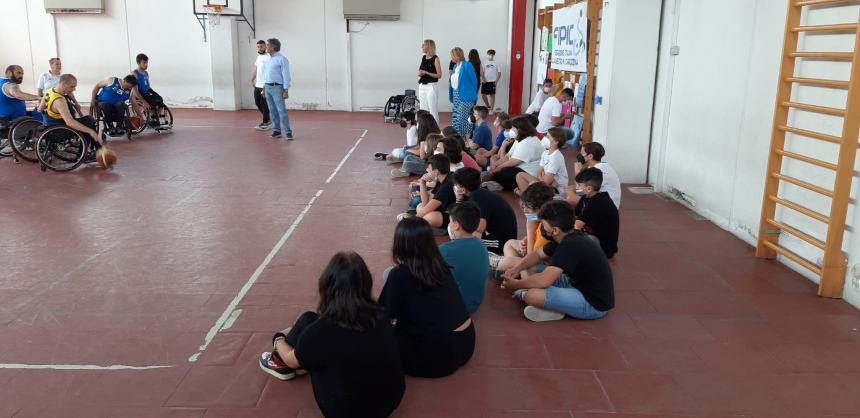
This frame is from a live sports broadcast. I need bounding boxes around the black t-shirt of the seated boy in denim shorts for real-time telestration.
[543,231,615,311]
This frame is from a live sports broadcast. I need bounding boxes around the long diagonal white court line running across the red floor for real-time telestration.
[188,129,367,363]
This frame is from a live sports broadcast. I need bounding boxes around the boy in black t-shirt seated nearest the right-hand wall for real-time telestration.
[574,167,619,258]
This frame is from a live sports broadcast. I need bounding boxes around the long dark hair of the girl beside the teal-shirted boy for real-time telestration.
[391,217,451,289]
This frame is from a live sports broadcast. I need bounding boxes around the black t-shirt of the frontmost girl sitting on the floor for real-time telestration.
[295,317,406,418]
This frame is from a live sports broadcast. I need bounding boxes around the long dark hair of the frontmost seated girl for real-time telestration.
[317,251,383,332]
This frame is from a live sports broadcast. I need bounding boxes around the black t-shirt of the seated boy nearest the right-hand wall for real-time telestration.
[576,192,619,258]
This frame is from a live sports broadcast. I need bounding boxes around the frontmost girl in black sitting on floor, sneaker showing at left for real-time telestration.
[260,252,406,418]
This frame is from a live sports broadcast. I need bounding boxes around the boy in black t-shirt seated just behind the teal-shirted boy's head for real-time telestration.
[415,154,457,229]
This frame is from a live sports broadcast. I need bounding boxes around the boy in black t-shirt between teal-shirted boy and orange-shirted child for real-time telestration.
[451,167,517,255]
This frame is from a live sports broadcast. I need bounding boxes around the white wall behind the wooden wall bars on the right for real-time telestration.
[650,0,860,306]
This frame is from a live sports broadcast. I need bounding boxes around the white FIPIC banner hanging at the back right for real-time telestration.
[550,1,588,73]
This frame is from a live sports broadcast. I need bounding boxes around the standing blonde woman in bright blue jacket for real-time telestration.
[448,47,478,137]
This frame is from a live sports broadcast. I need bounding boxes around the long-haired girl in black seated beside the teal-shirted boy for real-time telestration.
[379,217,475,377]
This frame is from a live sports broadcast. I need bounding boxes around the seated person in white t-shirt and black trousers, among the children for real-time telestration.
[485,116,544,191]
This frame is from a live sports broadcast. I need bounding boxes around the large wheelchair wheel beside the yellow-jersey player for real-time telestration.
[36,126,89,171]
